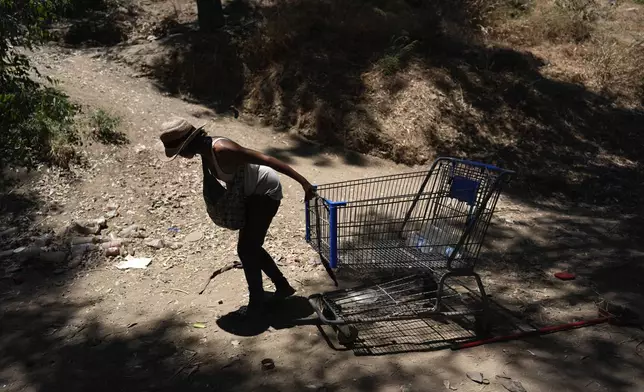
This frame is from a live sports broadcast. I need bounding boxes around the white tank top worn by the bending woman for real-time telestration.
[211,137,283,200]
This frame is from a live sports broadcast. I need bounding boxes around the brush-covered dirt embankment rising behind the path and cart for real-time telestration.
[102,0,644,208]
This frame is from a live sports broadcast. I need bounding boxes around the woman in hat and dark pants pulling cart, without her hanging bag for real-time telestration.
[161,118,315,314]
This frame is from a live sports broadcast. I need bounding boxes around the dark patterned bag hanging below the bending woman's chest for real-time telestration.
[201,158,246,230]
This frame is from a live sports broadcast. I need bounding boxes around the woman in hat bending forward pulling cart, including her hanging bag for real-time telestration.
[160,118,315,316]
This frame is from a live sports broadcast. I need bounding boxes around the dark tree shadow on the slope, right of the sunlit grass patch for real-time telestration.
[418,46,644,212]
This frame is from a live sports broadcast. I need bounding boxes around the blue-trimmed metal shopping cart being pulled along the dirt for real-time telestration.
[305,158,513,344]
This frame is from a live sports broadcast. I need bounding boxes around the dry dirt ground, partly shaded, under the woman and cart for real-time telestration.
[0,49,644,392]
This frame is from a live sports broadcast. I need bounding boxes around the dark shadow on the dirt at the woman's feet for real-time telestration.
[217,296,317,336]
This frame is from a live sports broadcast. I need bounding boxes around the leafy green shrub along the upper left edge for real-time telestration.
[0,0,78,166]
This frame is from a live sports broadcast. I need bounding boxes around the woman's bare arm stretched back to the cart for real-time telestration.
[215,140,315,200]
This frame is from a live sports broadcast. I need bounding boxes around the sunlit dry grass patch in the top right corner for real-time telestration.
[487,0,644,101]
